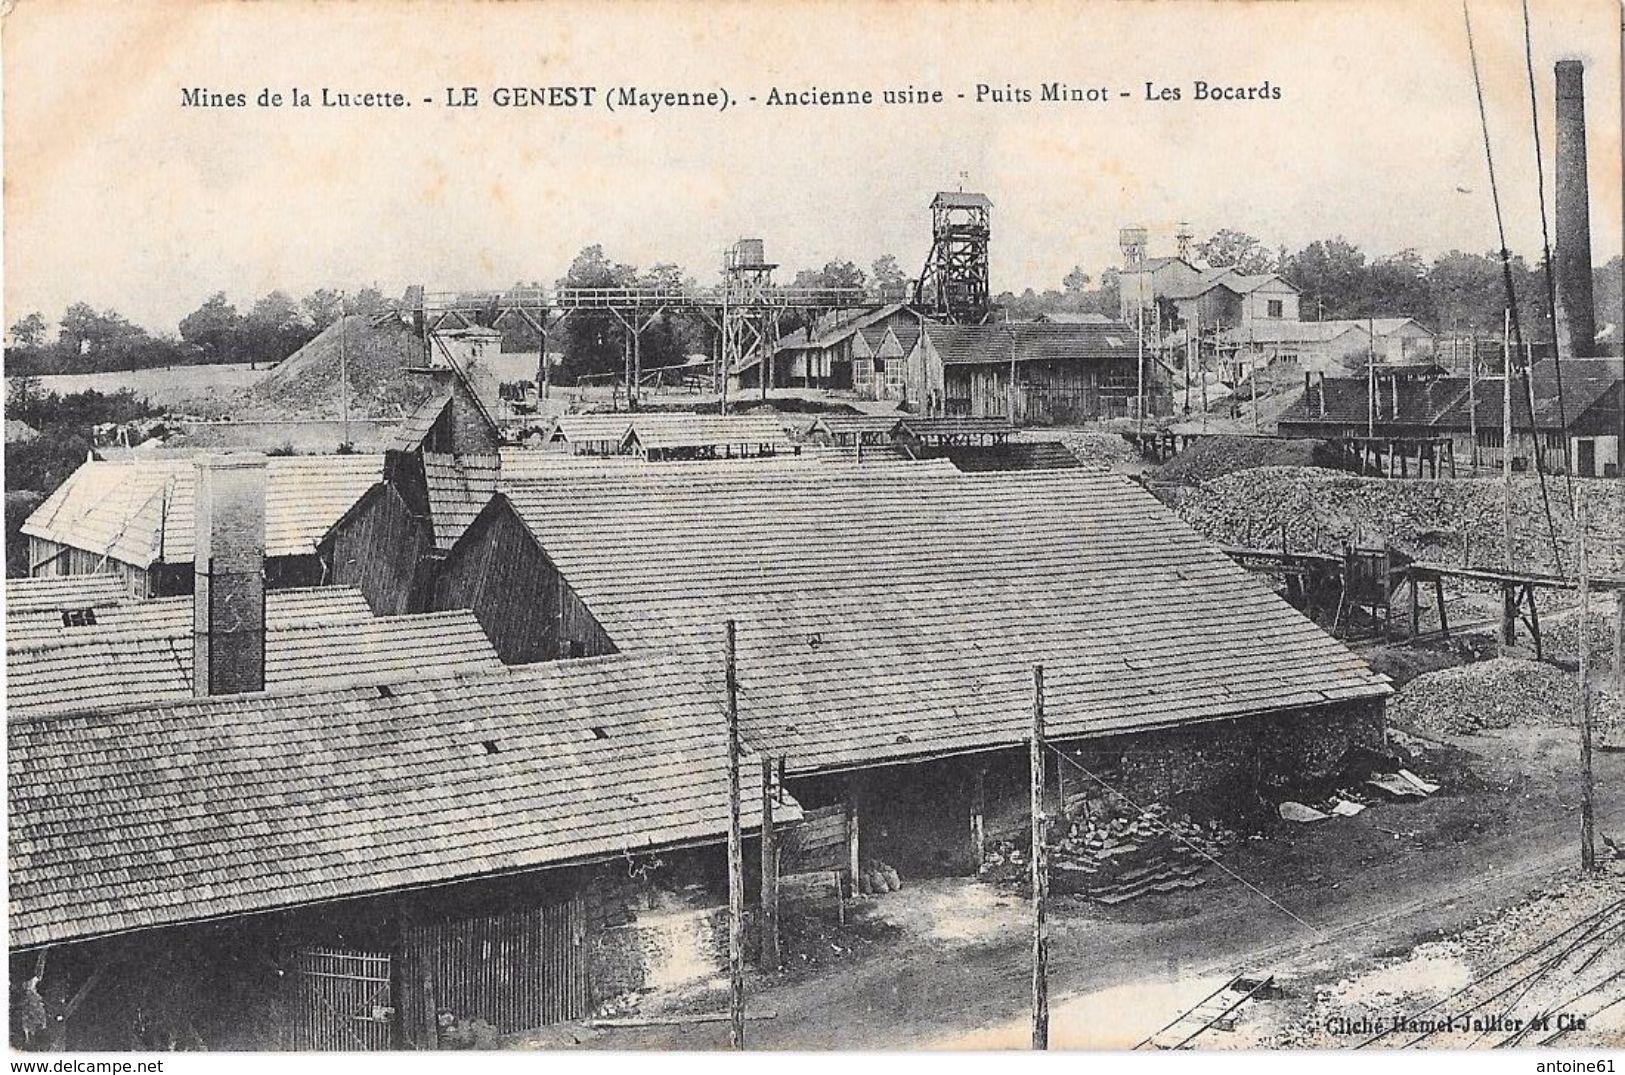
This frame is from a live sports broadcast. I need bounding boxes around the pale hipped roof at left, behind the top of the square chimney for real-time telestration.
[23,455,384,567]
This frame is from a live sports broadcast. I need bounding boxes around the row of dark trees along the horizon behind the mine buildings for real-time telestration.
[7,229,1625,383]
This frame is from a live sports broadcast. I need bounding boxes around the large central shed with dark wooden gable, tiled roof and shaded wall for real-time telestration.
[323,375,1389,870]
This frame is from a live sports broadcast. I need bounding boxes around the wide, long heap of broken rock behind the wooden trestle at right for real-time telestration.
[1164,466,1625,575]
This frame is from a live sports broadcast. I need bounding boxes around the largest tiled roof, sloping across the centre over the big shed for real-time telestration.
[505,464,1388,771]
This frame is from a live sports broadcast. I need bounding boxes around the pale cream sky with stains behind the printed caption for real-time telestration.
[0,0,1622,331]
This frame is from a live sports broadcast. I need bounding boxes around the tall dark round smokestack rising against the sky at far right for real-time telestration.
[1554,60,1597,357]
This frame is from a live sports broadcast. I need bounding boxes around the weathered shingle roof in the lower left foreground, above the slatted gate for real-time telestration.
[7,656,800,947]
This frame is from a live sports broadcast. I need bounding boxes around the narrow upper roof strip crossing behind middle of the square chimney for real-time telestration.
[5,591,372,648]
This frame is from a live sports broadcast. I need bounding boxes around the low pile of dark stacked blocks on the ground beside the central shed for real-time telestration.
[982,804,1237,904]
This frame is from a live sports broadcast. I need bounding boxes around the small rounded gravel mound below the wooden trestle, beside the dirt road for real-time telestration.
[1388,658,1580,736]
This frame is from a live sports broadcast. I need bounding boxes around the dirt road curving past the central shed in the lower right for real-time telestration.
[587,729,1625,1049]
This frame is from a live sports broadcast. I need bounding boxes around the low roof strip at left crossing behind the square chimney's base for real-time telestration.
[5,609,501,719]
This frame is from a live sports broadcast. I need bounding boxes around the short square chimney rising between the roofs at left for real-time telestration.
[192,455,267,698]
